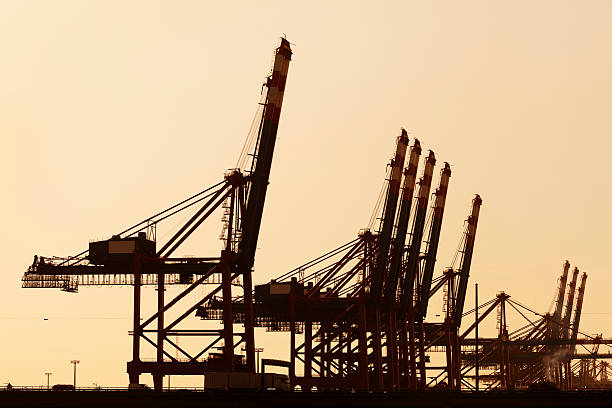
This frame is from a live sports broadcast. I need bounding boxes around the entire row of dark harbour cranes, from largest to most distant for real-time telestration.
[16,39,604,391]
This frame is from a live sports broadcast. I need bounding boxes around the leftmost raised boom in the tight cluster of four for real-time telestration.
[371,129,408,302]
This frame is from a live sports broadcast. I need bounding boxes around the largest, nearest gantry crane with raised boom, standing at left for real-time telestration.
[23,38,292,390]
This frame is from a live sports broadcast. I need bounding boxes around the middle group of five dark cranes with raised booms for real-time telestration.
[198,129,482,390]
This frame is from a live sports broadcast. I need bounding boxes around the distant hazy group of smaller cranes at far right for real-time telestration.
[460,261,612,390]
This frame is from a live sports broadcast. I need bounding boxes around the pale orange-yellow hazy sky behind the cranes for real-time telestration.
[0,0,612,386]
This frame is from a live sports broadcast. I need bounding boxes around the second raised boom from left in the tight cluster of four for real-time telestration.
[385,139,421,305]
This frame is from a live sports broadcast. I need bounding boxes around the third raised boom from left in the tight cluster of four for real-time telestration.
[401,150,436,312]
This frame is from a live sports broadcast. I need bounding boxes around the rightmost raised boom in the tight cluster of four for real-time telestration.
[417,163,451,318]
